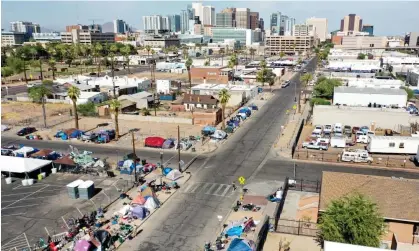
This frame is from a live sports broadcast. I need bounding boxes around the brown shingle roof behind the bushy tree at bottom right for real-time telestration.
[319,172,419,222]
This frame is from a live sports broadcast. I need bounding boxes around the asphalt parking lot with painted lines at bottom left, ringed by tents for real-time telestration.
[1,174,132,250]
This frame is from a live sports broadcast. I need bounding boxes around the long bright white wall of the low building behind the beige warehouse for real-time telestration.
[333,92,407,107]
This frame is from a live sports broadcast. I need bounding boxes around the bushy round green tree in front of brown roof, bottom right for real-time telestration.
[318,194,386,247]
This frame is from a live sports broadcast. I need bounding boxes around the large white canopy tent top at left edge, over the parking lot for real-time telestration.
[0,156,52,173]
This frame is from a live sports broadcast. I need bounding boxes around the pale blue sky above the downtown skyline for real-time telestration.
[1,1,419,35]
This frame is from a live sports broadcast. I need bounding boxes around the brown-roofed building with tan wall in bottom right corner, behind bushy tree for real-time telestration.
[319,172,419,246]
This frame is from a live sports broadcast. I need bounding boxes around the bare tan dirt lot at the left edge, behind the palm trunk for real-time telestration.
[1,102,71,126]
